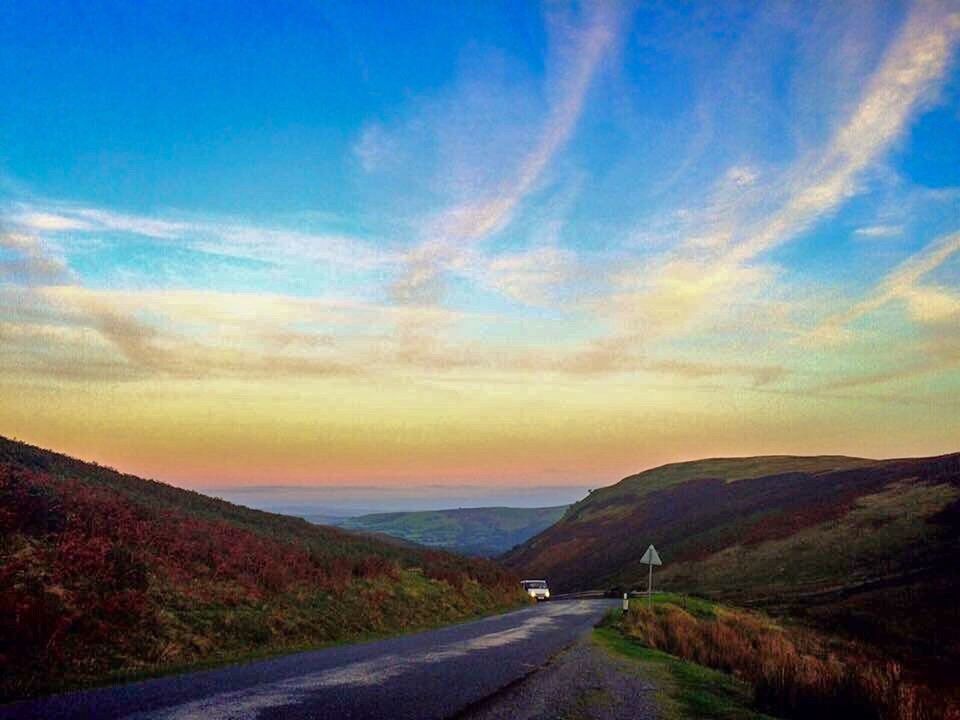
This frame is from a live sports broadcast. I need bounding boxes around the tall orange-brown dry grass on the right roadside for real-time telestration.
[621,603,960,720]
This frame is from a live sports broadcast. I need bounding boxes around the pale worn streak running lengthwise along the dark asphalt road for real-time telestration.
[126,601,594,720]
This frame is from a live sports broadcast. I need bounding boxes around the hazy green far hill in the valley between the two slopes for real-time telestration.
[336,505,567,557]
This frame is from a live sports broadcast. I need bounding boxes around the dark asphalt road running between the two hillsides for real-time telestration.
[0,600,616,720]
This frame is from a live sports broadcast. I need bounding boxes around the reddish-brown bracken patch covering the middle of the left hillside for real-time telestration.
[0,467,388,611]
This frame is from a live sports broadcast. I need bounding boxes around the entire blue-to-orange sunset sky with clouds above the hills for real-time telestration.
[0,0,960,488]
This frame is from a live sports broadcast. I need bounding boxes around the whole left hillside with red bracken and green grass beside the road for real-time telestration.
[0,438,520,699]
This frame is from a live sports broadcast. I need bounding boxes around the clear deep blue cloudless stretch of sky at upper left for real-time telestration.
[2,2,543,216]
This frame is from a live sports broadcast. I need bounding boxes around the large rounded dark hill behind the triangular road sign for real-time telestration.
[502,454,960,669]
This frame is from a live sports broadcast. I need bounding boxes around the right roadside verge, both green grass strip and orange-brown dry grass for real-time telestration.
[602,594,960,720]
